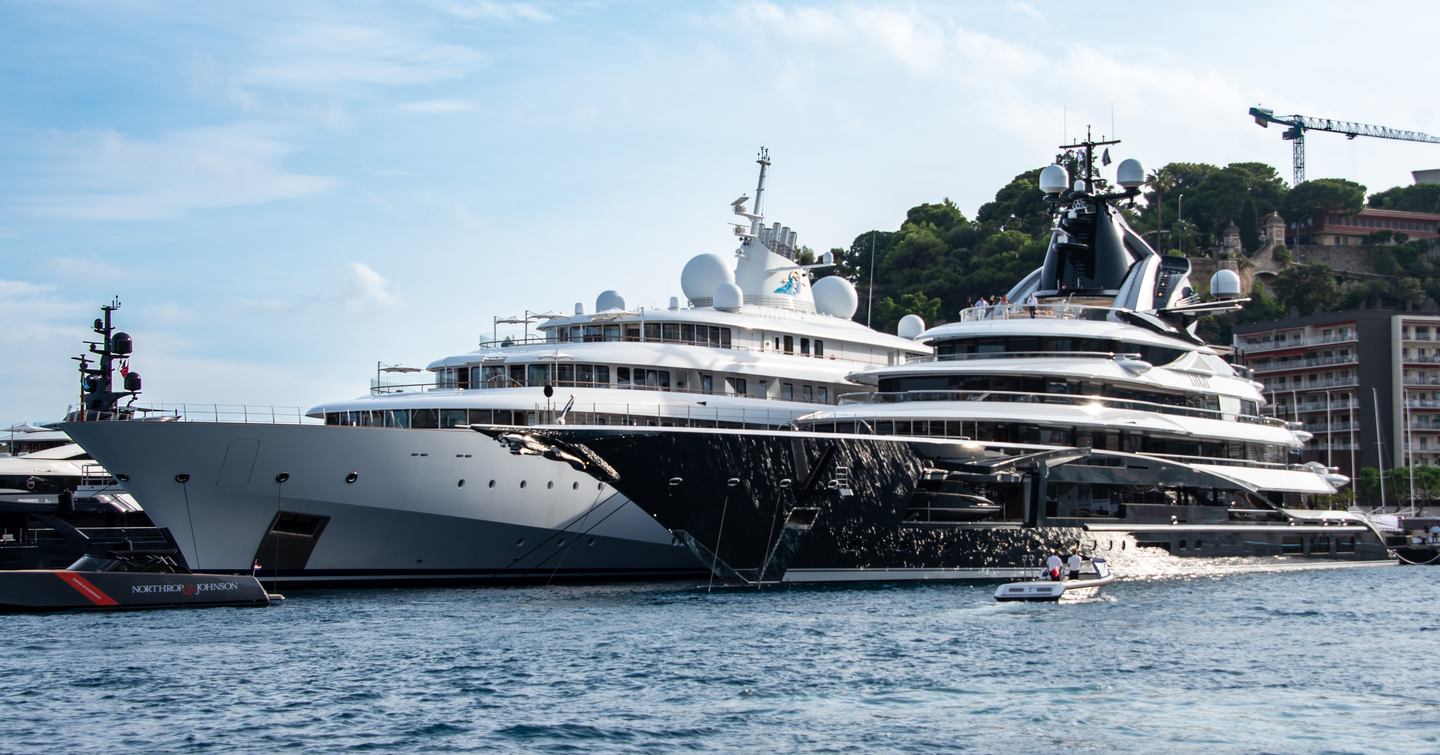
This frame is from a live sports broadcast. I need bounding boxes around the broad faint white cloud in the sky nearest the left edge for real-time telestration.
[20,124,337,220]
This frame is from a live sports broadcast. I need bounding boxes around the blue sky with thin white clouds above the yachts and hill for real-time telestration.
[0,0,1440,426]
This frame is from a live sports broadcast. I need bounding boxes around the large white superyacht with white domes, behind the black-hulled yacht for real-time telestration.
[65,151,930,584]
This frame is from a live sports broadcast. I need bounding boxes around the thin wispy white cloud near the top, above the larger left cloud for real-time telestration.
[239,24,485,91]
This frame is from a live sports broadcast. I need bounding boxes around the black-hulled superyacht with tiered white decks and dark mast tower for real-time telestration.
[498,140,1388,584]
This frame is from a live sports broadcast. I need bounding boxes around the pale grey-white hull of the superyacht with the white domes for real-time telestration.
[66,421,701,585]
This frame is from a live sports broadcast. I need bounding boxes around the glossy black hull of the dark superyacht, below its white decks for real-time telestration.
[531,428,1388,584]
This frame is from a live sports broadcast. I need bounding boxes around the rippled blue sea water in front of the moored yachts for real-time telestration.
[0,566,1440,752]
